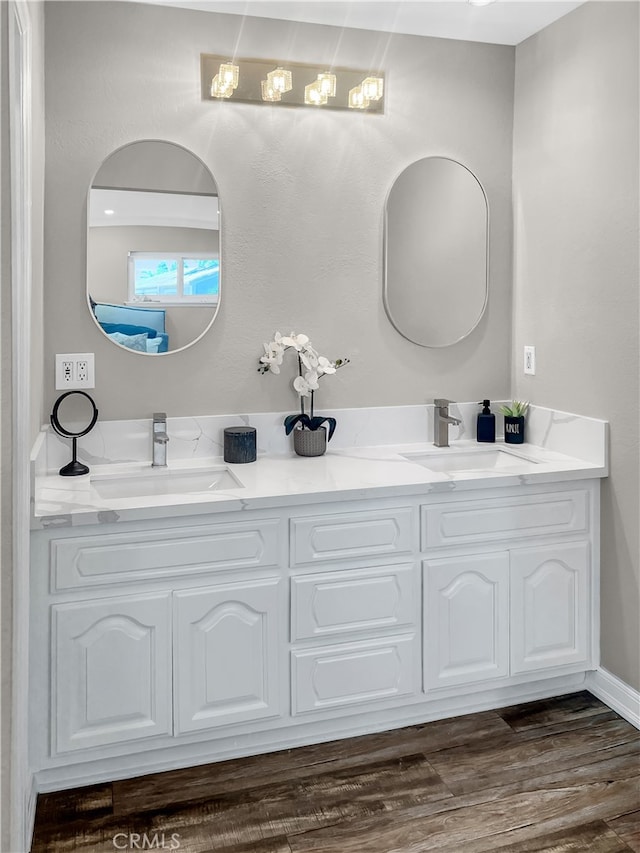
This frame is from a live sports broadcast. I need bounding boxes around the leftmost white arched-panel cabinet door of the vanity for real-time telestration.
[52,593,171,753]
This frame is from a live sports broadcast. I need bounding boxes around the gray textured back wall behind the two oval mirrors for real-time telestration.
[44,2,514,420]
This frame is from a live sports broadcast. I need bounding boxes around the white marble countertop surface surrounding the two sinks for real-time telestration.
[32,440,607,529]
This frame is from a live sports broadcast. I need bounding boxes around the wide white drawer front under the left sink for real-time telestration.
[51,519,279,592]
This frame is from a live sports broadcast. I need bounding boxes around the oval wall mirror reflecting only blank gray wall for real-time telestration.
[383,157,489,347]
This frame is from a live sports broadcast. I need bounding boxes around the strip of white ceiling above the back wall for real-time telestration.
[143,0,582,45]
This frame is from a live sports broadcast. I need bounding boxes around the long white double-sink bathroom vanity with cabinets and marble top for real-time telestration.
[30,410,606,790]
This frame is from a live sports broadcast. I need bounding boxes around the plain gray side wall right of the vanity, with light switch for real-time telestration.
[513,3,640,689]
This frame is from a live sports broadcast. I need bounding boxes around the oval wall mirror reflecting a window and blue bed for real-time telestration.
[87,139,220,355]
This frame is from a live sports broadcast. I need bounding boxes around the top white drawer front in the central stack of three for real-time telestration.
[291,507,413,566]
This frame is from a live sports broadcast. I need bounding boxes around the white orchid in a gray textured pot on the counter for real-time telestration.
[258,332,349,456]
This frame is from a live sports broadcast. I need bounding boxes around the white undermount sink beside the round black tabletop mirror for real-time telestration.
[91,466,243,498]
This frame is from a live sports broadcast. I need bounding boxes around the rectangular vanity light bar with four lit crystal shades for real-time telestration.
[200,53,386,114]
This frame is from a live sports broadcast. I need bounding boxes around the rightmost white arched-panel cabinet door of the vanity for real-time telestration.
[511,542,589,674]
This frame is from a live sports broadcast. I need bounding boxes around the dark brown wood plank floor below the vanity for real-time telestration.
[32,692,640,853]
